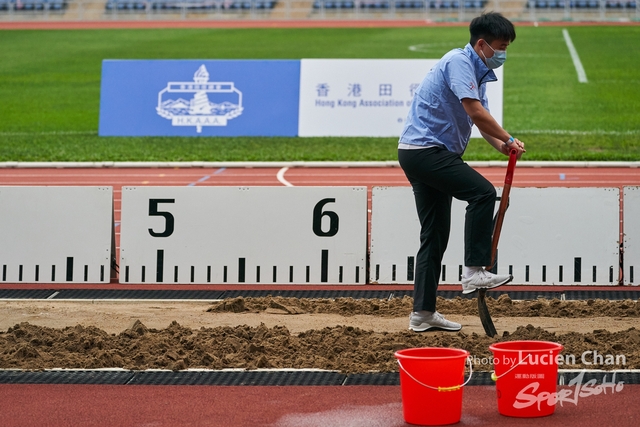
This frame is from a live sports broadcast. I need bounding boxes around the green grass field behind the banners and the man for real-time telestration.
[0,26,640,161]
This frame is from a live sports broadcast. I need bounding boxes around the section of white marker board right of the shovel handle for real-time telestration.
[498,187,620,285]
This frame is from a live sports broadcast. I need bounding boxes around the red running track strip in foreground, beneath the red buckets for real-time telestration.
[0,384,640,427]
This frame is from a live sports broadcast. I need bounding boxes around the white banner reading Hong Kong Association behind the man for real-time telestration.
[298,59,504,138]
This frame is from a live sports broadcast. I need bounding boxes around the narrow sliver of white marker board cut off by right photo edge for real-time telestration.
[623,187,640,286]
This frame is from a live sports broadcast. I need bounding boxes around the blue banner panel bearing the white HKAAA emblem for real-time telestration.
[99,60,300,136]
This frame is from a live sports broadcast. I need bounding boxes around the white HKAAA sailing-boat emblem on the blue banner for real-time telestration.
[156,64,243,133]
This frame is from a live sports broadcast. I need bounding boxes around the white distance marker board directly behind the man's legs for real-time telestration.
[370,187,627,285]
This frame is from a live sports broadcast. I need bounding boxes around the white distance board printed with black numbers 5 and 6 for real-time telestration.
[120,187,367,284]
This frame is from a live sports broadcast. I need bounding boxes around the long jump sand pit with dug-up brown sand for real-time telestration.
[0,295,640,373]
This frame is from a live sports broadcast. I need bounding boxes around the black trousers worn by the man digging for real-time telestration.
[398,147,496,311]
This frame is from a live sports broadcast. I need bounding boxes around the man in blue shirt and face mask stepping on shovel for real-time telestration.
[398,13,525,332]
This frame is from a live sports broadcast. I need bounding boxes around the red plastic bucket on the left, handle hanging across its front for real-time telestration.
[395,347,471,426]
